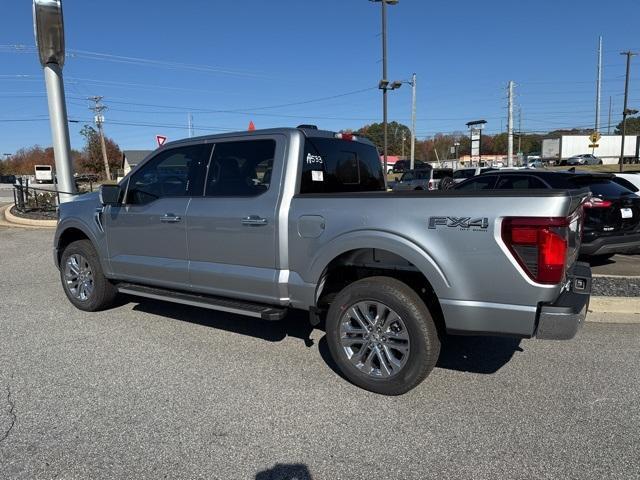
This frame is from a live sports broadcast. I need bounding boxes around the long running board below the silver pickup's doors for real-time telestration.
[118,283,287,320]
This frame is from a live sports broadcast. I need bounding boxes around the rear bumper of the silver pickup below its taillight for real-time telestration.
[535,262,591,340]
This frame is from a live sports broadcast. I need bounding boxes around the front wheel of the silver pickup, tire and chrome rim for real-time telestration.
[60,240,118,312]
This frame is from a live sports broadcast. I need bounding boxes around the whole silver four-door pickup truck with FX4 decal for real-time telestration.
[54,127,591,395]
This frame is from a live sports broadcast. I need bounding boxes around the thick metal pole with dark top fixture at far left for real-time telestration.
[33,0,76,202]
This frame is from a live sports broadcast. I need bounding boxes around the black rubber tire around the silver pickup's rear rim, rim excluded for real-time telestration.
[326,277,440,395]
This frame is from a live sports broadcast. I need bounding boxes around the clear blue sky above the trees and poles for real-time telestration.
[0,0,640,153]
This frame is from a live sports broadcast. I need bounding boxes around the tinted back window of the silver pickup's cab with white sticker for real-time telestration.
[300,137,386,194]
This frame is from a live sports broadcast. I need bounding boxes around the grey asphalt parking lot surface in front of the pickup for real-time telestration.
[0,228,640,480]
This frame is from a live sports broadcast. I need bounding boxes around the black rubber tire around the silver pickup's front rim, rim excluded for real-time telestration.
[60,240,118,312]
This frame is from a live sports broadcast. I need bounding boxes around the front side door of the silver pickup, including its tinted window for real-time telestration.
[104,144,212,288]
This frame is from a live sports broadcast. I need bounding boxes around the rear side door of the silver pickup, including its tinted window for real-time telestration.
[187,135,285,302]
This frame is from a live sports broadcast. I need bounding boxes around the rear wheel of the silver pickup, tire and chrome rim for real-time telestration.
[326,277,440,395]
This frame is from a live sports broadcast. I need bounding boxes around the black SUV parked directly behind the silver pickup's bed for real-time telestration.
[454,170,640,257]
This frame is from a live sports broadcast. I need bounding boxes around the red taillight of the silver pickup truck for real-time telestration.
[502,217,571,284]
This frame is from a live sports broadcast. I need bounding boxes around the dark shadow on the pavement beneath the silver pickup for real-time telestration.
[129,298,523,376]
